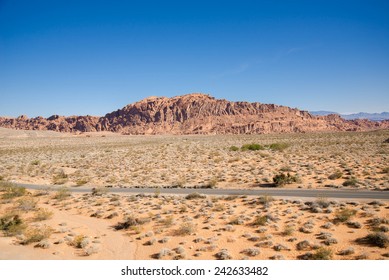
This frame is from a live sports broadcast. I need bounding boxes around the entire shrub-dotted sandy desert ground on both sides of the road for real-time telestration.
[0,129,389,260]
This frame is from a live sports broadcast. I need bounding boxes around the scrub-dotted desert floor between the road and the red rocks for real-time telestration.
[0,129,389,189]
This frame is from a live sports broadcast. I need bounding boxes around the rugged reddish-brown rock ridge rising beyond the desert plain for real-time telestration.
[0,93,389,134]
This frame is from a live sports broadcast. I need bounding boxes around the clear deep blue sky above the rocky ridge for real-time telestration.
[0,0,389,117]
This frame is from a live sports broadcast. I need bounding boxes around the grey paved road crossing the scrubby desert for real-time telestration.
[18,184,389,200]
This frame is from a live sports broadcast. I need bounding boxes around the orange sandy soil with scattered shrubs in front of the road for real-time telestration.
[0,188,389,260]
